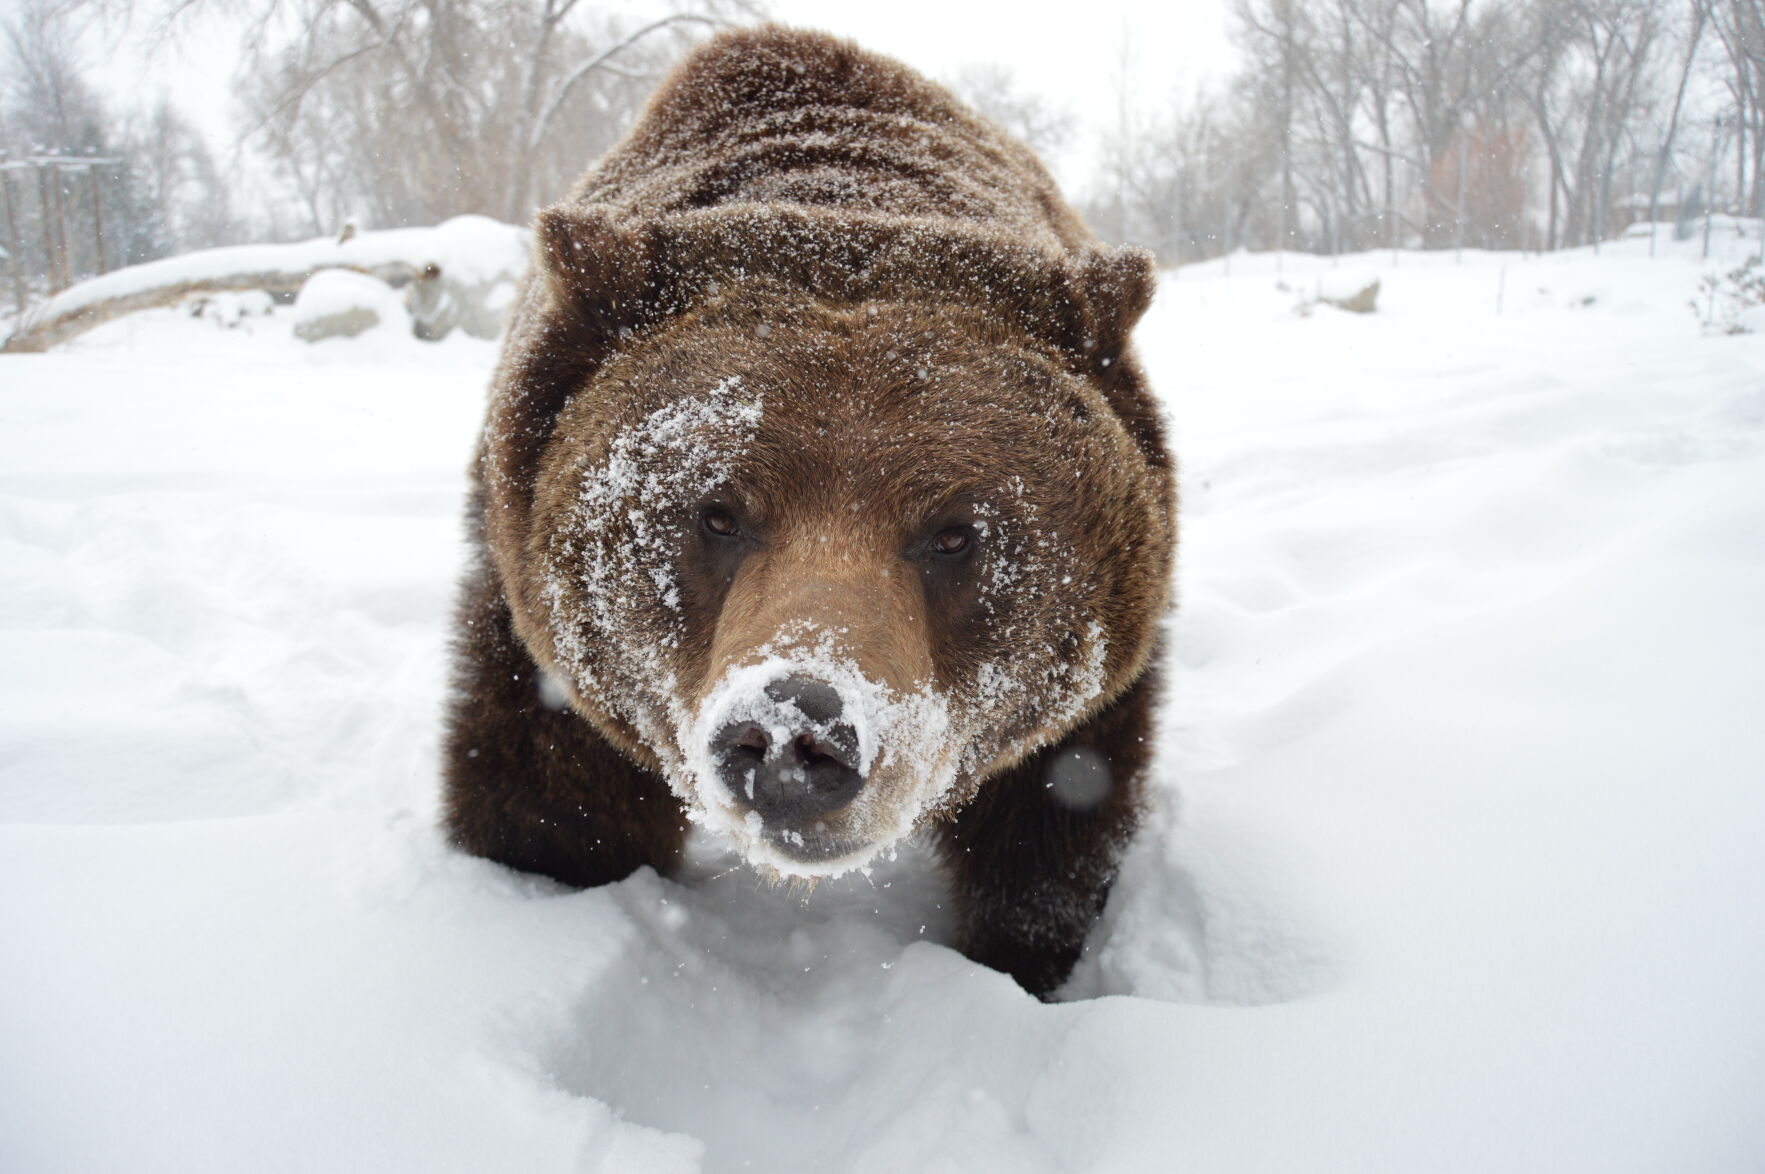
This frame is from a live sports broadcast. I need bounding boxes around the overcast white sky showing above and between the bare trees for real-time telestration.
[0,0,1232,189]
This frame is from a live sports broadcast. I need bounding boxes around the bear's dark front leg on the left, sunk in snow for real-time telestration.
[443,558,687,888]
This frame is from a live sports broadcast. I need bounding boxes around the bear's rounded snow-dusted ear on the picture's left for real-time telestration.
[533,205,658,346]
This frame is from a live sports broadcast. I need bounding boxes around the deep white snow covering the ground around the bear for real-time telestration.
[0,231,1765,1174]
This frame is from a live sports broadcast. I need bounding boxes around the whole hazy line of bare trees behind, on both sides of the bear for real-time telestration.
[0,0,1765,304]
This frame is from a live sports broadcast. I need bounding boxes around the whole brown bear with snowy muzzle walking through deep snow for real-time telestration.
[445,28,1175,997]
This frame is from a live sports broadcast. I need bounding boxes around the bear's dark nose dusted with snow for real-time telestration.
[711,676,865,828]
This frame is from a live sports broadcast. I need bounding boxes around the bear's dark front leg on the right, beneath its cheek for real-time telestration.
[939,671,1156,999]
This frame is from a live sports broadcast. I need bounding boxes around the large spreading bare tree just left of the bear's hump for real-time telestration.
[232,0,740,230]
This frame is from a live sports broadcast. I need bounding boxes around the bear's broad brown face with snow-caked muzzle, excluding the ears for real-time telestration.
[514,291,1168,874]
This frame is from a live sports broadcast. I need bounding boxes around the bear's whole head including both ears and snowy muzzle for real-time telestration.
[484,210,1172,876]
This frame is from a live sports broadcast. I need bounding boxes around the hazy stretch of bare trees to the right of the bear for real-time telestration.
[1089,0,1765,261]
